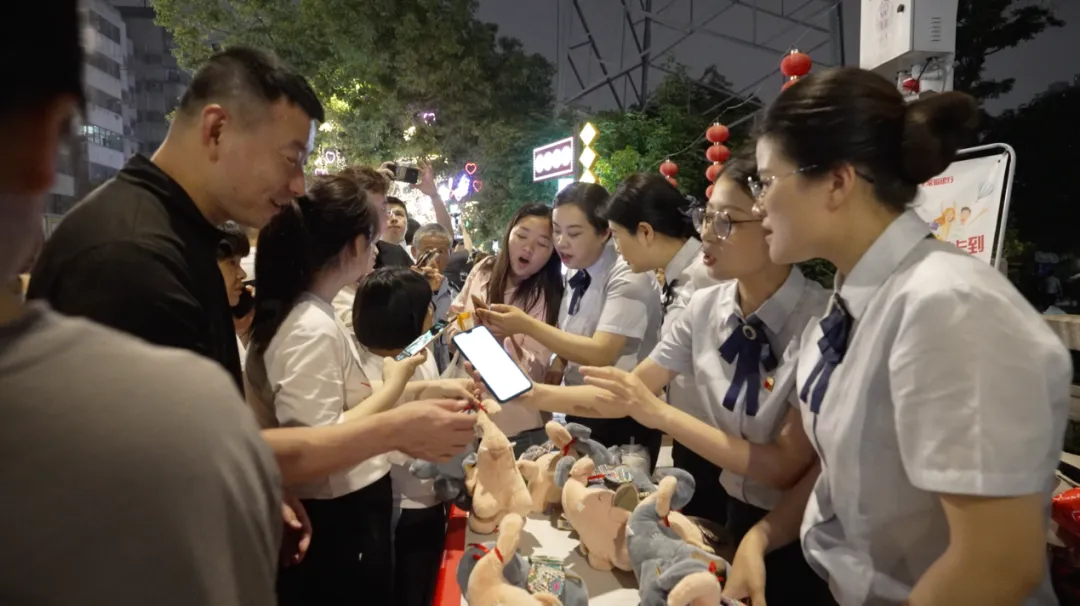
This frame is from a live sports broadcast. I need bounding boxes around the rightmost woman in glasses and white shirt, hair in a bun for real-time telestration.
[732,68,1071,606]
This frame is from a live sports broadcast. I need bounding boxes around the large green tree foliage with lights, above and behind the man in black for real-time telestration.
[154,0,554,239]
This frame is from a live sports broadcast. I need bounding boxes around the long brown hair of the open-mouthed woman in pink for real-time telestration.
[475,203,561,326]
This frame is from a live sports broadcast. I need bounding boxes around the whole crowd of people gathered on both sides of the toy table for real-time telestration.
[0,0,1071,606]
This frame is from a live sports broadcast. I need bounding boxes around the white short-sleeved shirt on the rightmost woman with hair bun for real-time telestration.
[798,212,1071,606]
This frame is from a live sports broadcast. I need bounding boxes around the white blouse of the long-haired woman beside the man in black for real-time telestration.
[259,293,390,499]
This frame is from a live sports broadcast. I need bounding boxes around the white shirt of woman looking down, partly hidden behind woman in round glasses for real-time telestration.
[660,238,719,427]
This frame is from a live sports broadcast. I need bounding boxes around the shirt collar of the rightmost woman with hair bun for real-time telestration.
[835,211,930,320]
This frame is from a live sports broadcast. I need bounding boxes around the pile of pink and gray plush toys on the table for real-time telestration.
[421,401,738,606]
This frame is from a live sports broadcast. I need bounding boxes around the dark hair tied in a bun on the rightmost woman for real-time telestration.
[757,67,978,211]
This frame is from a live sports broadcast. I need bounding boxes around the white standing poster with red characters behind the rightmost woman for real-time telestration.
[915,144,1016,269]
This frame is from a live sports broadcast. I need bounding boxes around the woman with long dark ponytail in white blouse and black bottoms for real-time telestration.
[246,171,451,606]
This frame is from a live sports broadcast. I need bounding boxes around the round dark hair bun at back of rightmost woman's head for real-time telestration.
[901,91,978,184]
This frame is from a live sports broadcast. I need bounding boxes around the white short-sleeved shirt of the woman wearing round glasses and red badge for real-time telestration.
[649,267,828,510]
